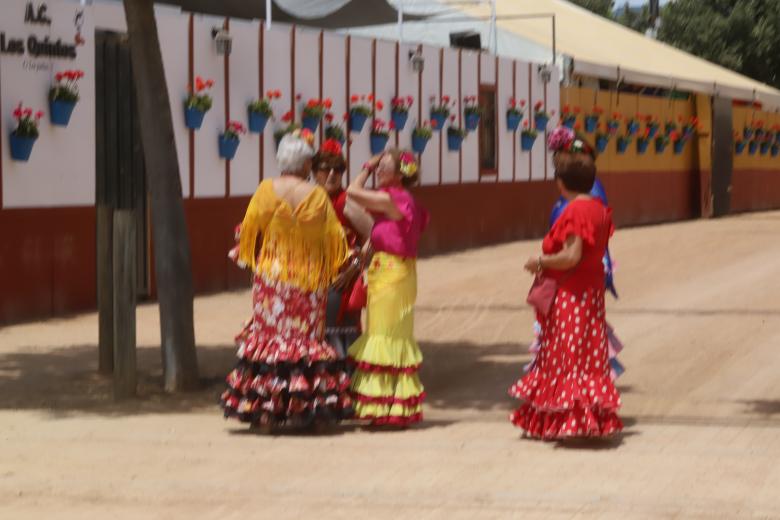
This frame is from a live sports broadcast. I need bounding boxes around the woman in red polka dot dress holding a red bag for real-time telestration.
[509,127,623,440]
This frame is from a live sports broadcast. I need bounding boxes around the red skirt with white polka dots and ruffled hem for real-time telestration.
[509,289,623,440]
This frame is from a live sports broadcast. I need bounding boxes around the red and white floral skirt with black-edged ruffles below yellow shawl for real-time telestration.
[221,276,353,424]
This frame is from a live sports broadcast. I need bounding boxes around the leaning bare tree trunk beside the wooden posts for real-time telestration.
[124,0,199,392]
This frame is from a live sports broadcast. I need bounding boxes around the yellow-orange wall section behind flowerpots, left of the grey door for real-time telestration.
[561,87,696,173]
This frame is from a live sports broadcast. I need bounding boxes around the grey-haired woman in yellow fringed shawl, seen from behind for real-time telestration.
[221,131,353,426]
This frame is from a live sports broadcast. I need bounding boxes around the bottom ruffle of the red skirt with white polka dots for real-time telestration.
[509,403,623,440]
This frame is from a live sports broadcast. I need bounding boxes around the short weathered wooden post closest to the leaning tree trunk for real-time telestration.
[113,209,137,400]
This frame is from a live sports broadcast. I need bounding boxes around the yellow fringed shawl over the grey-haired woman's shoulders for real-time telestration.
[238,179,349,291]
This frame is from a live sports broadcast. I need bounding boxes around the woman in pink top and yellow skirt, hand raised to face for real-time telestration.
[347,150,428,427]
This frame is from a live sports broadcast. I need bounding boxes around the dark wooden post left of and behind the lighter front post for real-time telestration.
[97,204,114,374]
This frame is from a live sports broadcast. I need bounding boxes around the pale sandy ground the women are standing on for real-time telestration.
[0,212,780,520]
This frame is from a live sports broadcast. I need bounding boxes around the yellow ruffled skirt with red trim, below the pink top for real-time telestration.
[348,253,425,426]
